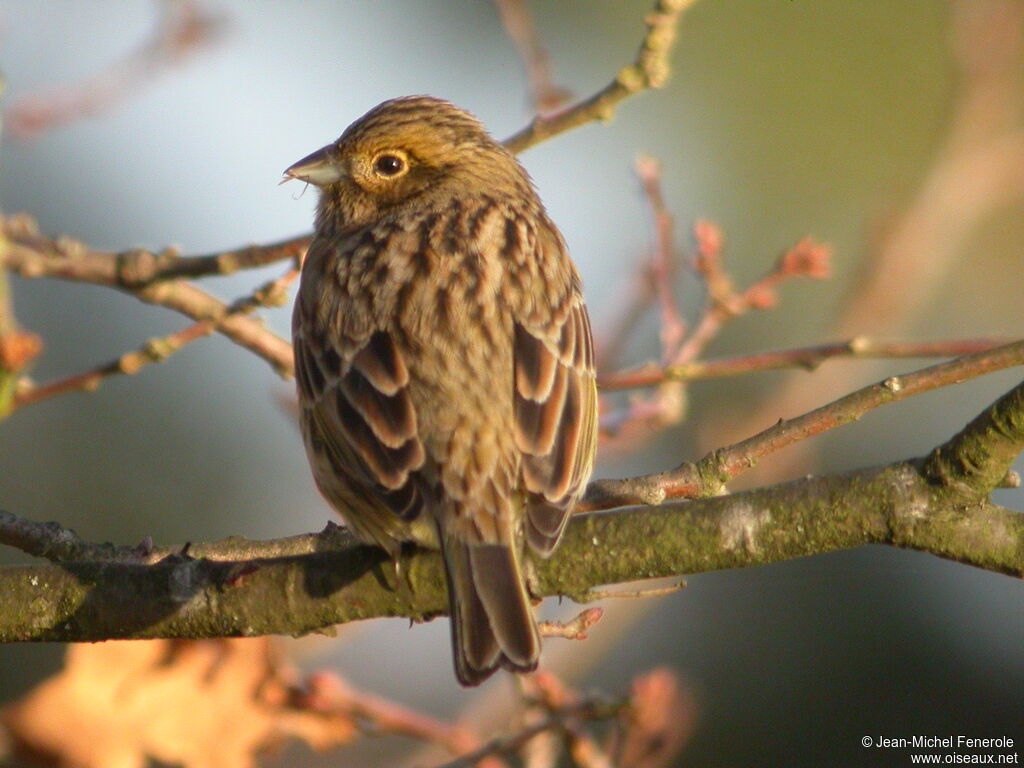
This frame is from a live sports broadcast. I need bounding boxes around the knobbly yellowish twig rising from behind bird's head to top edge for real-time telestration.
[505,0,696,154]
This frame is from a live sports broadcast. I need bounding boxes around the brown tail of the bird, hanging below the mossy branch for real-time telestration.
[442,536,541,685]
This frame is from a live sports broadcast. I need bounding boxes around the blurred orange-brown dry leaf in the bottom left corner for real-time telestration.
[0,638,357,768]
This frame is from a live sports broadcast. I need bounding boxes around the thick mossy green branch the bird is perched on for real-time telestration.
[0,372,1024,642]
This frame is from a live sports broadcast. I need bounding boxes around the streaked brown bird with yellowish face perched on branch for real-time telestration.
[284,96,597,686]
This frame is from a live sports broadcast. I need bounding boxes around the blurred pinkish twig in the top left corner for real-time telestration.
[6,0,224,138]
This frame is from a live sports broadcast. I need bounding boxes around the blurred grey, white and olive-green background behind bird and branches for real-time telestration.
[0,0,1024,768]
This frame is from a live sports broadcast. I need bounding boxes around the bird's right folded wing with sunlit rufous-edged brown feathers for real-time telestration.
[514,287,597,555]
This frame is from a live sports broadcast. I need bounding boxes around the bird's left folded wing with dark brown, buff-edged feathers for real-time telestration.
[295,323,425,551]
